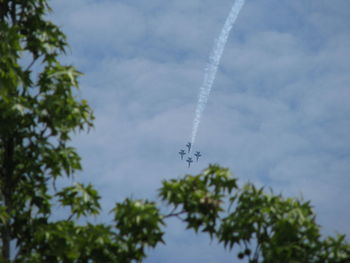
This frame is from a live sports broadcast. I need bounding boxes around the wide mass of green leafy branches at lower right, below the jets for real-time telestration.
[160,165,350,263]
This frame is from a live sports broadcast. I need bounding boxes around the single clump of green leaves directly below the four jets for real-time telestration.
[159,166,237,236]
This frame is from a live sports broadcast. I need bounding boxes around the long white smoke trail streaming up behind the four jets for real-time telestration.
[191,0,245,147]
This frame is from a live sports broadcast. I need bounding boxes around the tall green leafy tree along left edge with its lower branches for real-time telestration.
[0,0,162,262]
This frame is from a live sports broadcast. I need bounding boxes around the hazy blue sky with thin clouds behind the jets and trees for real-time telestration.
[47,0,350,263]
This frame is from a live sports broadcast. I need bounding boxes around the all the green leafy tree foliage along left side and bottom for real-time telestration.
[0,0,350,263]
